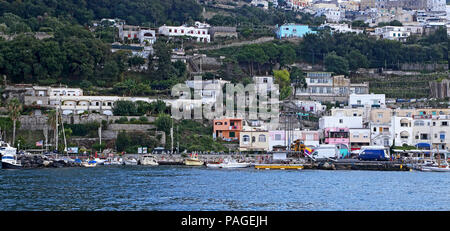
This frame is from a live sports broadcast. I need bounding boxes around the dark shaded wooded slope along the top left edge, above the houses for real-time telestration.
[0,0,201,26]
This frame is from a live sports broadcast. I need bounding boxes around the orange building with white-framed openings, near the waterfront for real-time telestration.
[213,119,242,141]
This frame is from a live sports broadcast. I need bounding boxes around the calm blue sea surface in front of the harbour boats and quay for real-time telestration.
[0,166,450,211]
